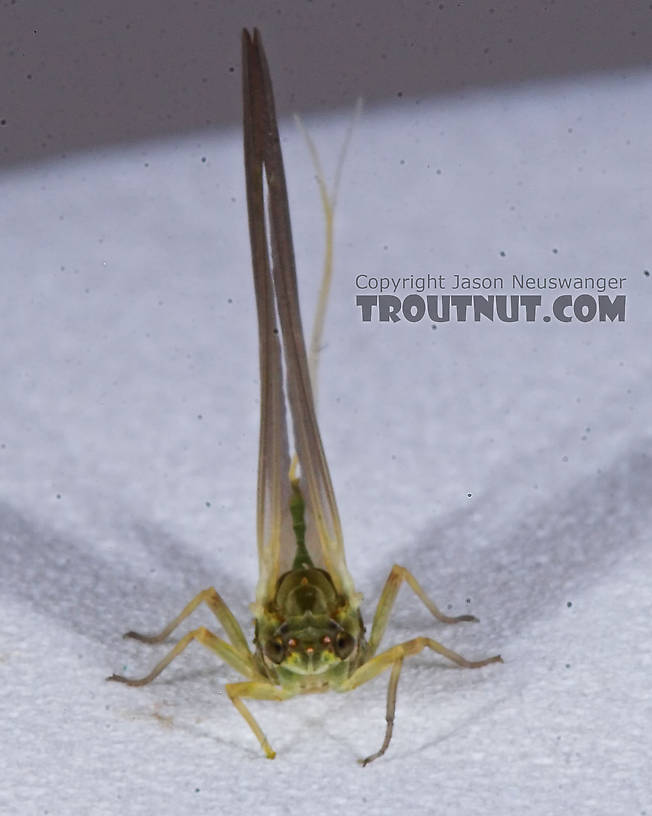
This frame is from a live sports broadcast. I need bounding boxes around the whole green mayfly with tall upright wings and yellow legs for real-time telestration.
[108,30,501,765]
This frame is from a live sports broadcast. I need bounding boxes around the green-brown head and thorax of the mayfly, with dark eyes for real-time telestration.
[255,567,364,690]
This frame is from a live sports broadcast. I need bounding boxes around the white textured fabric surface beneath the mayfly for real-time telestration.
[0,67,652,816]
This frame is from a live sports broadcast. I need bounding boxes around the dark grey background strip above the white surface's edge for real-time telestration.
[0,0,652,169]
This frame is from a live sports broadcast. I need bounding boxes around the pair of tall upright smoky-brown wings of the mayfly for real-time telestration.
[242,31,354,605]
